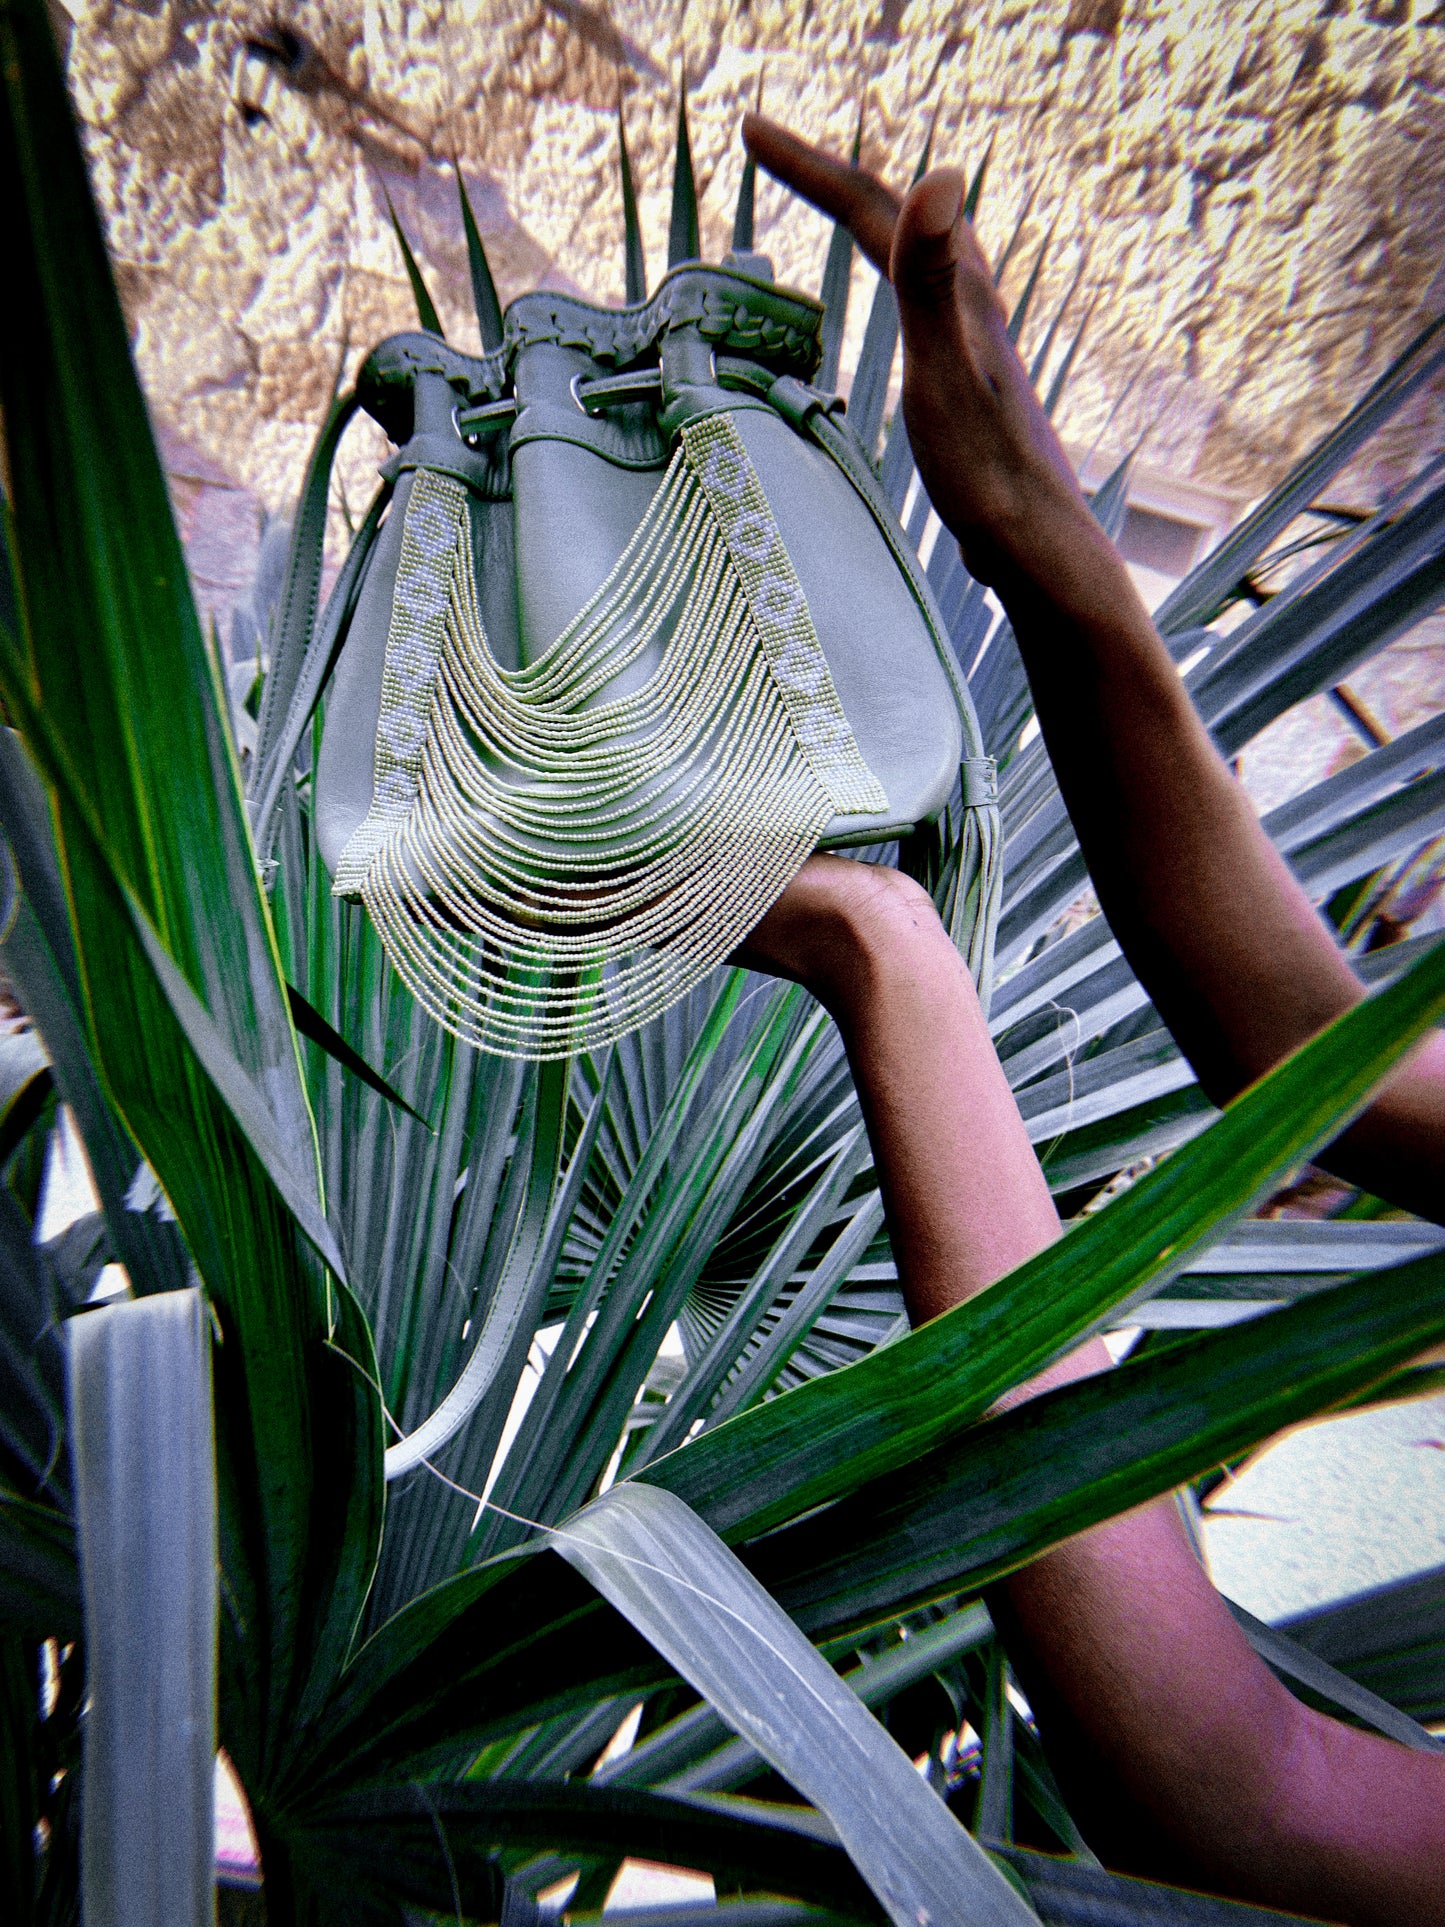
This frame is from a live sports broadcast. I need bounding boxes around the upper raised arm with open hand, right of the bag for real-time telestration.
[744,116,1445,1222]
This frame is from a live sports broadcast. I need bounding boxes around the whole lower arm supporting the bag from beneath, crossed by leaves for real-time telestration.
[742,856,1445,1927]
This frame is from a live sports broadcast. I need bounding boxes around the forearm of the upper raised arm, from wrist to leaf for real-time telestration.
[1000,516,1445,1216]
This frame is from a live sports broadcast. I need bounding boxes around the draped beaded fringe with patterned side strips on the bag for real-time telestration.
[333,414,888,1060]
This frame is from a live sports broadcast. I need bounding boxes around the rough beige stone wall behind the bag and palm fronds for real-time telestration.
[52,0,1445,662]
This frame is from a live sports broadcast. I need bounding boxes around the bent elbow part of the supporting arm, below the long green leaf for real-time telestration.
[988,1343,1445,1927]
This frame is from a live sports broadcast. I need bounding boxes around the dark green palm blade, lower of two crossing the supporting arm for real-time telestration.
[757,1256,1445,1638]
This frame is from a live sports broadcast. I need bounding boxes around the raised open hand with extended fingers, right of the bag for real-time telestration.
[742,114,1119,597]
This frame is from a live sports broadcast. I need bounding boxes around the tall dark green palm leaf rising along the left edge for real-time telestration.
[0,4,380,1784]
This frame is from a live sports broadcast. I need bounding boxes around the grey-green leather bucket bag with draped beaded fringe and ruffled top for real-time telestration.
[254,256,998,1058]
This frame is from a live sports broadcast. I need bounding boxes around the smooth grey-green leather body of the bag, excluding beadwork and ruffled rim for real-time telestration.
[314,269,963,871]
